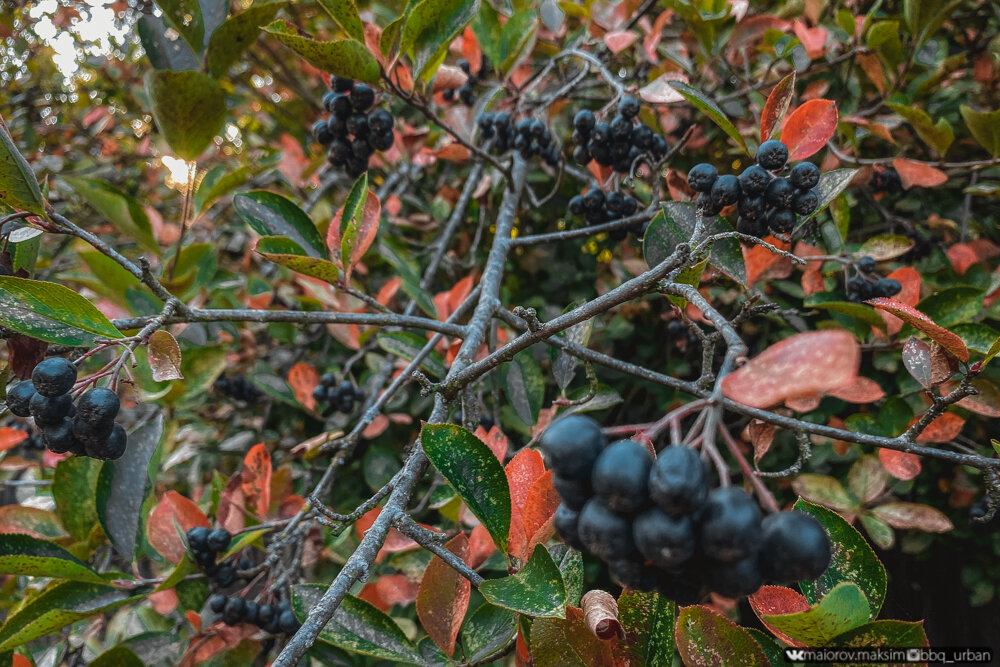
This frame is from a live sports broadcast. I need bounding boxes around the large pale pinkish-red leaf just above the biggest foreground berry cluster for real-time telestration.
[722,330,861,408]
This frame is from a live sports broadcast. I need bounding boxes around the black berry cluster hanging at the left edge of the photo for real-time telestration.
[7,357,128,460]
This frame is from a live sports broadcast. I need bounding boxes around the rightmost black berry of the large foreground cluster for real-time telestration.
[759,510,830,583]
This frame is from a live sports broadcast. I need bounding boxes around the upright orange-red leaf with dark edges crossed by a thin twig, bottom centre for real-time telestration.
[417,533,472,658]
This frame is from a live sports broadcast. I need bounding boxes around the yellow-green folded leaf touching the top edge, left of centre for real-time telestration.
[400,0,479,80]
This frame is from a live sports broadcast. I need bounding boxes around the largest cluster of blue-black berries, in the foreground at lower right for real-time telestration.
[541,415,830,604]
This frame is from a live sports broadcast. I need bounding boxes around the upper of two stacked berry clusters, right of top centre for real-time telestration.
[573,95,668,174]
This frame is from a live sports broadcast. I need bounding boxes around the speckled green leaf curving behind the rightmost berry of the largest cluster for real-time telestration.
[795,500,886,618]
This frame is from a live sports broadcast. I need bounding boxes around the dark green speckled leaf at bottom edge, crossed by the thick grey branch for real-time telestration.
[292,584,423,665]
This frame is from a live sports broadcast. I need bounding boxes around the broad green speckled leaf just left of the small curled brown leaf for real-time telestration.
[479,544,566,618]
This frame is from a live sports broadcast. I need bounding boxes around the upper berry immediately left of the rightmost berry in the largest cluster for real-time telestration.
[698,486,761,563]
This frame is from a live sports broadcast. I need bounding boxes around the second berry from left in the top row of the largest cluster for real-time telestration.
[591,440,653,514]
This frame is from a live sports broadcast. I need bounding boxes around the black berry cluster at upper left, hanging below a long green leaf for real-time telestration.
[313,76,395,178]
